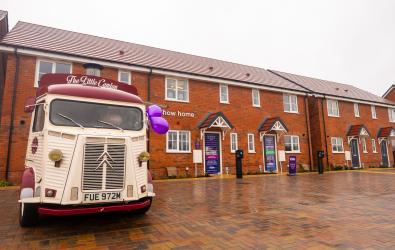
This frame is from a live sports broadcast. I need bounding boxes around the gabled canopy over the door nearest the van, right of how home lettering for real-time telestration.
[198,112,233,140]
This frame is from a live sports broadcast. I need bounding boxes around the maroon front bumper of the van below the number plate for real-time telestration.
[38,199,151,216]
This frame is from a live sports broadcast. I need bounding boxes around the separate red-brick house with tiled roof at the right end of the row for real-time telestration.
[271,71,395,168]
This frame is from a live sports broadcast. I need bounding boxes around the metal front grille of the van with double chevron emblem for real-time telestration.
[82,144,125,191]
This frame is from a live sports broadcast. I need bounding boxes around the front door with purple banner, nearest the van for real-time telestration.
[204,133,221,174]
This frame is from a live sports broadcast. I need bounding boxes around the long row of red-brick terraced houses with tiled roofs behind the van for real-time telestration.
[0,9,395,182]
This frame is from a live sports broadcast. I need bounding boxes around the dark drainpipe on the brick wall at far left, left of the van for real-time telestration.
[5,48,19,181]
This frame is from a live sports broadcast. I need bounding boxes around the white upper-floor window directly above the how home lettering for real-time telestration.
[166,78,189,102]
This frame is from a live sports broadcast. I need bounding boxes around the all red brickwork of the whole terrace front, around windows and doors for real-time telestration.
[0,54,393,183]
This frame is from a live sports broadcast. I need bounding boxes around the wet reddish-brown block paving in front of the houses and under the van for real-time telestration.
[0,170,395,249]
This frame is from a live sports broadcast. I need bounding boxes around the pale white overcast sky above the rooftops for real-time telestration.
[0,0,395,96]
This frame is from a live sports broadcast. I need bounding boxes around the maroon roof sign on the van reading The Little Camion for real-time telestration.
[39,73,138,95]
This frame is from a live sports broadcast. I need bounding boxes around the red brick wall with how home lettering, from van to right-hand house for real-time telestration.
[150,75,309,178]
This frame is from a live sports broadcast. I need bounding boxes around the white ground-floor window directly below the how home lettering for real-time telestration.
[166,130,191,153]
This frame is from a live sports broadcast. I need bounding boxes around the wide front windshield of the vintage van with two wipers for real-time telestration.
[49,99,143,131]
